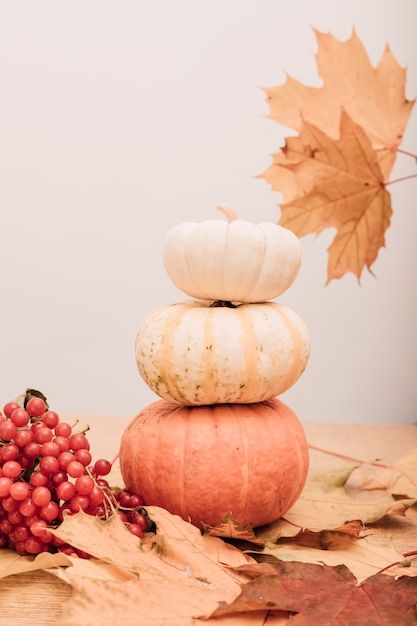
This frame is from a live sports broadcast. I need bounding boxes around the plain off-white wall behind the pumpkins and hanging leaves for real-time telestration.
[0,0,417,423]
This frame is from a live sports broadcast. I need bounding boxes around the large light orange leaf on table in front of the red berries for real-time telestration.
[50,507,252,626]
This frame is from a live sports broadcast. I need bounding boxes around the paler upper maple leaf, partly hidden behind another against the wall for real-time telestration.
[265,31,414,182]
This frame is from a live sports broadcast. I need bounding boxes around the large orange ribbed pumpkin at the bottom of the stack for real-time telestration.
[119,398,308,527]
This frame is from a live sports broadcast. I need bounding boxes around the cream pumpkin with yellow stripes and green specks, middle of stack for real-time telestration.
[135,301,310,405]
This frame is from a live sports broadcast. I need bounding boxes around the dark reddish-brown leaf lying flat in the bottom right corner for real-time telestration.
[216,561,417,626]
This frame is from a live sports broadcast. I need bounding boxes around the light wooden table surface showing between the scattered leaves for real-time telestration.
[0,414,417,626]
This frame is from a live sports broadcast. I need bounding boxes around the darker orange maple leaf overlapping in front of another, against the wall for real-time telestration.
[263,111,392,282]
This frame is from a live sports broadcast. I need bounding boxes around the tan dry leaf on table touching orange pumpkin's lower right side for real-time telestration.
[284,460,415,532]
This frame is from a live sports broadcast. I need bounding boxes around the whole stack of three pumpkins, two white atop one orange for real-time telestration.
[120,205,310,528]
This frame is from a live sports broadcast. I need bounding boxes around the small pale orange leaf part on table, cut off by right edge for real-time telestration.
[363,448,417,498]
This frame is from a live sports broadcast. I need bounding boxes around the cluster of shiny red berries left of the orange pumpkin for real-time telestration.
[0,390,149,557]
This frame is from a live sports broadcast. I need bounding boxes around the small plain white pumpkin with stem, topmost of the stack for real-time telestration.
[163,205,301,302]
